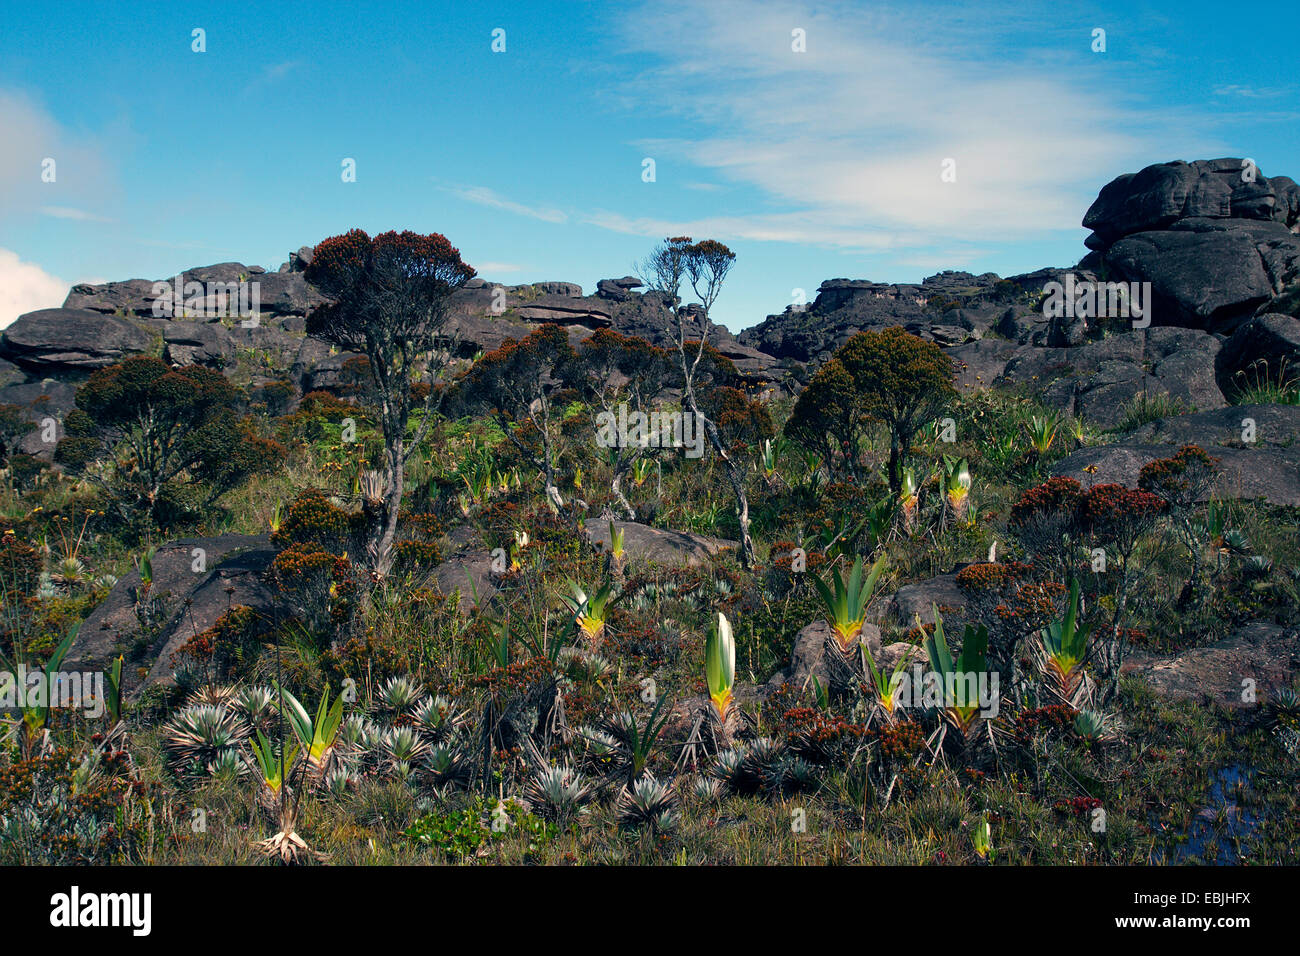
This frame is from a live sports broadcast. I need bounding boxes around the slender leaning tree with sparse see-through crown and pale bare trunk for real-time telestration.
[641,235,754,568]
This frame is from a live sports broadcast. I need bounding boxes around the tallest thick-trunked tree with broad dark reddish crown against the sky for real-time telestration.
[304,229,475,575]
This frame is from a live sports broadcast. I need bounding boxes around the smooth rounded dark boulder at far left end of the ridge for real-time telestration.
[0,308,153,377]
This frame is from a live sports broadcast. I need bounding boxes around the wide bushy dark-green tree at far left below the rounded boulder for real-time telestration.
[55,356,276,525]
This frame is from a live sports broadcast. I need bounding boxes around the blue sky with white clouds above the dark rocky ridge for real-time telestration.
[0,0,1300,330]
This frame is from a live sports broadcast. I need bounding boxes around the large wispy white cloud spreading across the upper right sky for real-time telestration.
[593,0,1205,250]
